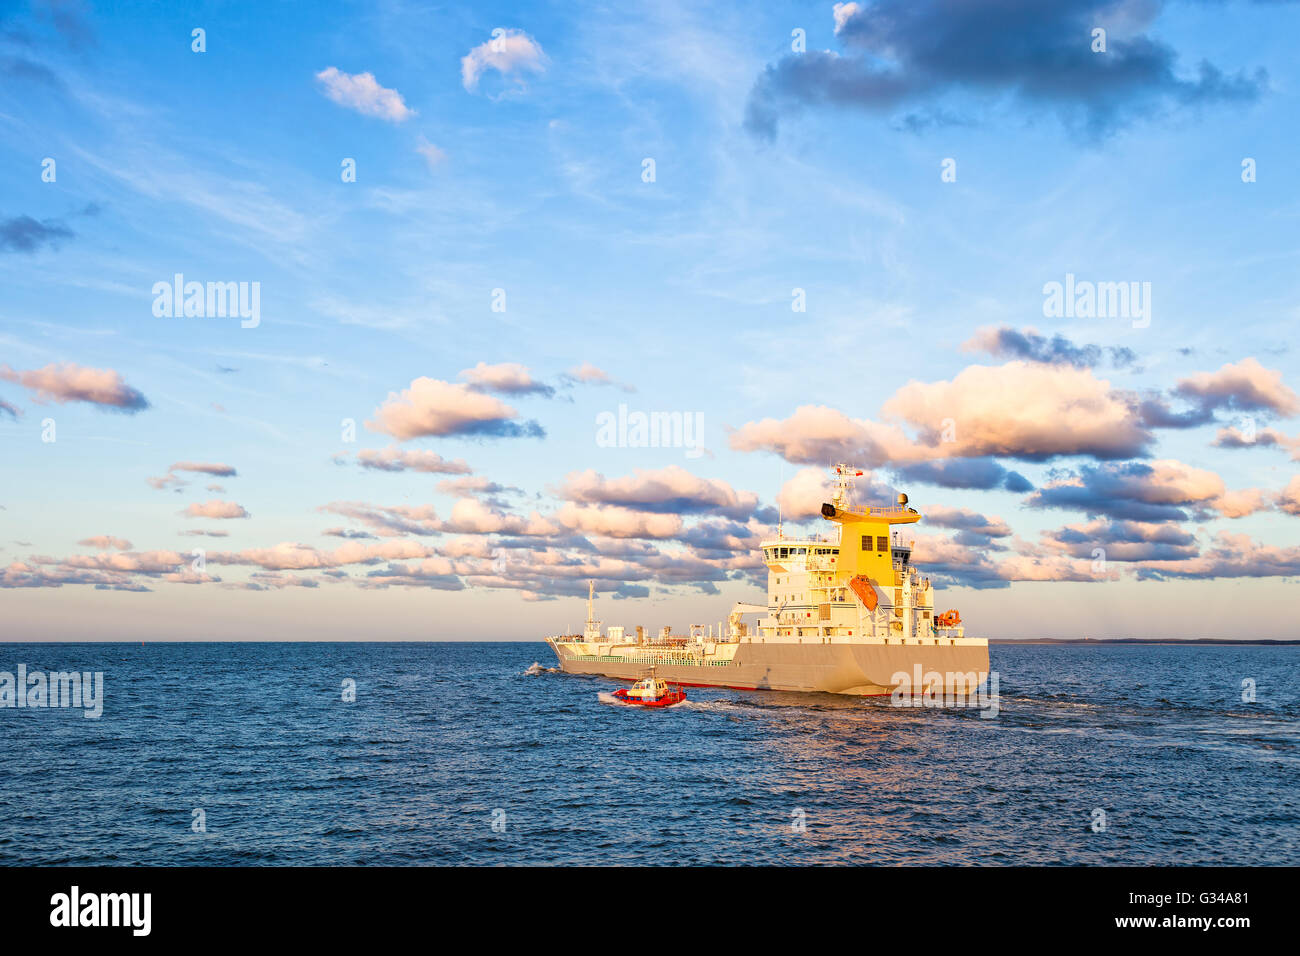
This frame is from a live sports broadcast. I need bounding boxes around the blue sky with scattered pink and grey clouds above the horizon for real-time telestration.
[0,0,1300,640]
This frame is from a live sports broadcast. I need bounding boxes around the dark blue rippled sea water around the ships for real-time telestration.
[0,643,1300,865]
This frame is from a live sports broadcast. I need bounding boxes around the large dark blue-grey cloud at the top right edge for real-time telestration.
[745,0,1268,139]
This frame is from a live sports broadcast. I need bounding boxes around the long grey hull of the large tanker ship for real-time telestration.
[550,640,988,696]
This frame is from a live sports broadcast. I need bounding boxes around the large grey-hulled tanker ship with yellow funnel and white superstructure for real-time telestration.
[546,464,988,696]
